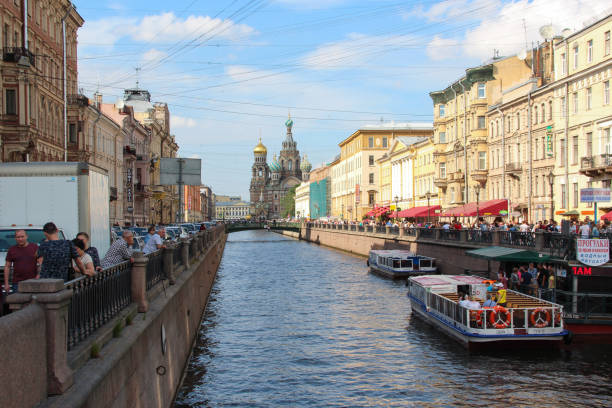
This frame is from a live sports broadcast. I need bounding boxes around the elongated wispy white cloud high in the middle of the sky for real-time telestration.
[301,33,415,69]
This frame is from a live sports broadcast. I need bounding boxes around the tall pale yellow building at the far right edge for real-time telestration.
[553,16,612,222]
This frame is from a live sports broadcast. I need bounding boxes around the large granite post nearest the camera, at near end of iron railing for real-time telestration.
[4,279,74,395]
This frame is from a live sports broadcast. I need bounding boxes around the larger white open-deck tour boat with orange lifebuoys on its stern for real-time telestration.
[408,275,568,348]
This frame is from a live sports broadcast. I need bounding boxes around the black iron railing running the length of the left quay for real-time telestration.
[64,226,224,350]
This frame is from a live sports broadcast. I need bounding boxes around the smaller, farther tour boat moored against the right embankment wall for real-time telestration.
[368,249,438,279]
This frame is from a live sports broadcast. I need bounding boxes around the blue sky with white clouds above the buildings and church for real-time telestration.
[74,0,612,199]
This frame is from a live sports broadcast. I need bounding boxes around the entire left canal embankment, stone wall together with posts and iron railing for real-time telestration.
[0,226,227,408]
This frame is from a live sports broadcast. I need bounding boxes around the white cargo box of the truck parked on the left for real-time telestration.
[0,162,110,258]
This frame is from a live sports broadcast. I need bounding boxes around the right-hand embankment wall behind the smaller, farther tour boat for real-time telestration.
[299,226,499,274]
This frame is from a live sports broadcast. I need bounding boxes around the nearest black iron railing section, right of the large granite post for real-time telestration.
[65,262,132,350]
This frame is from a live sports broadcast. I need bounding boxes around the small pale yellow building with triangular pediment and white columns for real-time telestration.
[377,134,438,210]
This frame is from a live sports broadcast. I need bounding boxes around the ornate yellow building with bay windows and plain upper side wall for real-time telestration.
[430,57,531,208]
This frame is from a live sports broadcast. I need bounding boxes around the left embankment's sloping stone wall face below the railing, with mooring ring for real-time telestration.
[43,234,226,408]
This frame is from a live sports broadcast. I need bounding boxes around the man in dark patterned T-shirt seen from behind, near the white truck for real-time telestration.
[37,222,85,281]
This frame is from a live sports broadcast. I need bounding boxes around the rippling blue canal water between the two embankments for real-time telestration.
[175,231,612,408]
